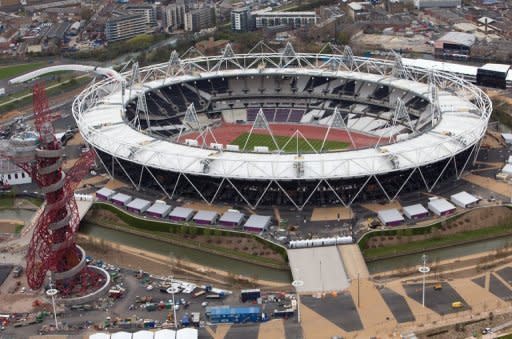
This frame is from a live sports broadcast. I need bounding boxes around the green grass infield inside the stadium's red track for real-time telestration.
[230,133,349,153]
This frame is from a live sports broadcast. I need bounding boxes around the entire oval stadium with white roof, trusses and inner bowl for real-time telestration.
[69,44,492,210]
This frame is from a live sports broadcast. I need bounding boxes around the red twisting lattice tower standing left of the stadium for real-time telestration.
[10,83,107,298]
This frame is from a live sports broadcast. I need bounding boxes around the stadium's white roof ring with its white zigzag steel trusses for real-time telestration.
[65,44,492,209]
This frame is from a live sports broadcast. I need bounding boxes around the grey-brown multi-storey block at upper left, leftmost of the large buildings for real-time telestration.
[105,14,146,42]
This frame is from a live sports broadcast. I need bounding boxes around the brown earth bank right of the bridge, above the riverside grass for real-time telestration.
[368,206,512,248]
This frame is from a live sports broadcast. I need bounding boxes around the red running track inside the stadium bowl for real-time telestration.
[177,123,379,148]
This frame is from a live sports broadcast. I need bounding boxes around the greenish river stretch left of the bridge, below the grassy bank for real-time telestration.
[80,223,292,283]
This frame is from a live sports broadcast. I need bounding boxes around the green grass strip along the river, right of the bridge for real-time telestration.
[363,225,512,259]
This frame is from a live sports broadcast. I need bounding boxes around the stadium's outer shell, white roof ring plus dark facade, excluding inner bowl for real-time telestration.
[73,44,492,210]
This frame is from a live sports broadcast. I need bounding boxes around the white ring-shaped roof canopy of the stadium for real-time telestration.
[78,68,488,180]
